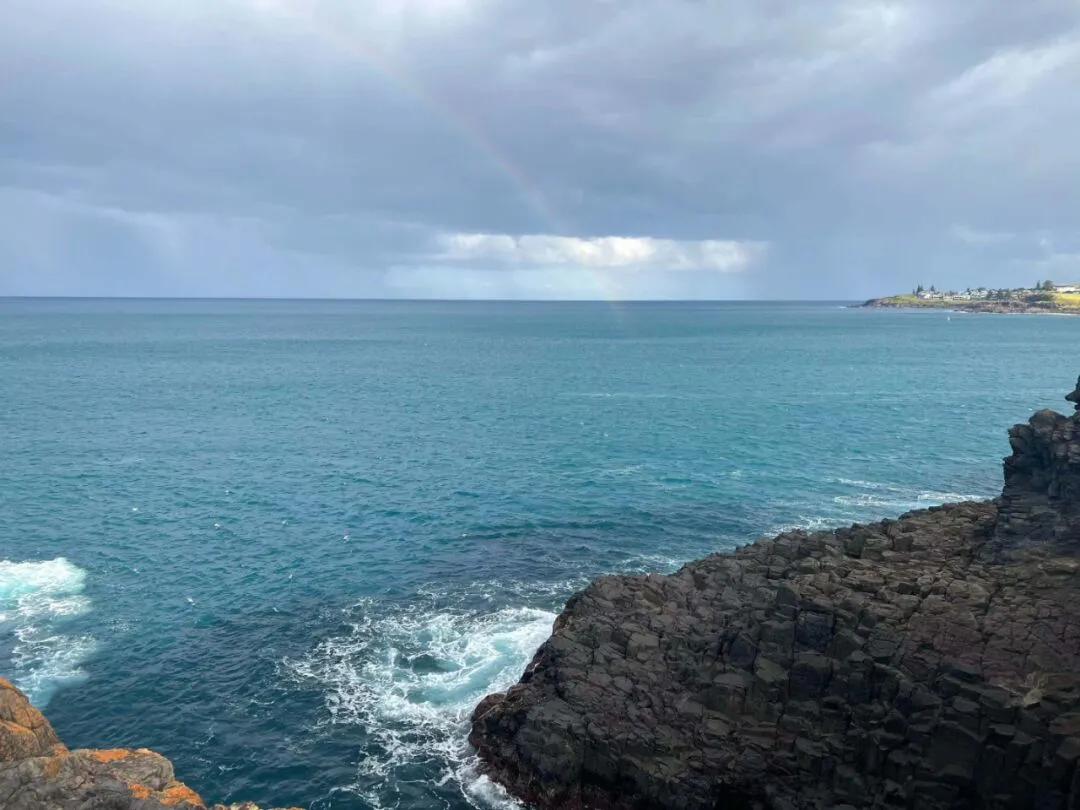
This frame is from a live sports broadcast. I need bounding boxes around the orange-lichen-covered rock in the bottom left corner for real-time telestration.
[0,678,295,810]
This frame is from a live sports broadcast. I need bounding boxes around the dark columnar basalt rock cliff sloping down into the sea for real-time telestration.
[470,383,1080,810]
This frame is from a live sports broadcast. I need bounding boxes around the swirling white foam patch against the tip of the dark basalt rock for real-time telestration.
[284,603,555,808]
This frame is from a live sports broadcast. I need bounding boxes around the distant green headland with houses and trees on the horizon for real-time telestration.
[862,281,1080,315]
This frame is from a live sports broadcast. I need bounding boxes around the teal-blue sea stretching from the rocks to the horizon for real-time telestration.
[0,299,1080,810]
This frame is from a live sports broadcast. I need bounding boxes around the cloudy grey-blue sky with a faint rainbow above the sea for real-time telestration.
[0,0,1080,300]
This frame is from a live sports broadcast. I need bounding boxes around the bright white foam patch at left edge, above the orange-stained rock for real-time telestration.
[0,557,94,706]
